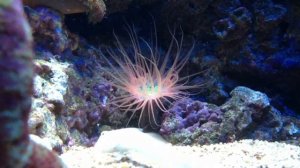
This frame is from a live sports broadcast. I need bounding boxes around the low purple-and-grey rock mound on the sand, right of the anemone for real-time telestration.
[160,86,300,145]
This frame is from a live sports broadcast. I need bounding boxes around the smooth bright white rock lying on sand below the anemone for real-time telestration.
[95,128,199,168]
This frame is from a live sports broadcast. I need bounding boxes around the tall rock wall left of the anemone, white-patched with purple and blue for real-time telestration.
[25,7,120,147]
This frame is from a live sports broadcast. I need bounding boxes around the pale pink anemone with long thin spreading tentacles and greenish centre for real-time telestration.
[105,29,199,128]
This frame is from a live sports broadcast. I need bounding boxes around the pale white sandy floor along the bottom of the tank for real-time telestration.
[61,129,300,168]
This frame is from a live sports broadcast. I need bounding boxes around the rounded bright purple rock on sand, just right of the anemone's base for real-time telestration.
[160,98,223,144]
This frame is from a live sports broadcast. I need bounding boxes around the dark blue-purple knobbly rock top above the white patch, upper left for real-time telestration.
[25,7,78,54]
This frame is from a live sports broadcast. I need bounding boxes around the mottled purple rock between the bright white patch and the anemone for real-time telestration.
[63,58,112,137]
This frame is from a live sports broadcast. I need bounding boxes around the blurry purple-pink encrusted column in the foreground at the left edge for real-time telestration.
[0,0,63,168]
